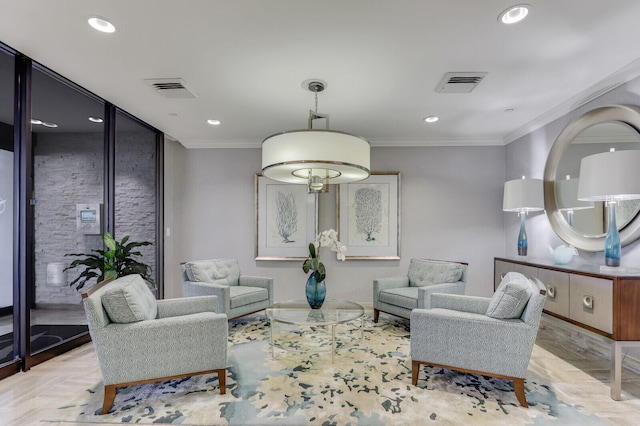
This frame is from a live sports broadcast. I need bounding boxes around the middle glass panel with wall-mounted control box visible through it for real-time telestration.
[30,66,105,362]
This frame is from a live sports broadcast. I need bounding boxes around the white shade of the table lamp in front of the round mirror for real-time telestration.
[578,150,640,201]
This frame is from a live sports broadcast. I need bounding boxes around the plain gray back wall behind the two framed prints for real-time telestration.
[164,142,505,303]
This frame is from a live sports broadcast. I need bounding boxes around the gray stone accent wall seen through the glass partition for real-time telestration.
[34,133,156,308]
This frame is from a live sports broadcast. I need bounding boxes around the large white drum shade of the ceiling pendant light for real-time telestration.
[262,129,371,184]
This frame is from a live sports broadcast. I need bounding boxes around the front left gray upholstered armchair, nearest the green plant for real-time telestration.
[82,275,228,414]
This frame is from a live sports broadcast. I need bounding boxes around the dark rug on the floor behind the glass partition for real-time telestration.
[0,324,89,364]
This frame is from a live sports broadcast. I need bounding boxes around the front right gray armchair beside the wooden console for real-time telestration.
[411,272,546,407]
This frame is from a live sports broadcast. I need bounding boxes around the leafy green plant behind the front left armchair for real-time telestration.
[64,232,156,289]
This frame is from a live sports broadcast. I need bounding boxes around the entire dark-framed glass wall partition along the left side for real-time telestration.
[0,39,163,378]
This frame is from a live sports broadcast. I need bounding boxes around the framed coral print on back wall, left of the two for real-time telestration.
[255,173,318,260]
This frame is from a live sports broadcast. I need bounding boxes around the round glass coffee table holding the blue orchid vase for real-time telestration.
[266,299,364,363]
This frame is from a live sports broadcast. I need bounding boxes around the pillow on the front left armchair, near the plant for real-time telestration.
[101,275,158,324]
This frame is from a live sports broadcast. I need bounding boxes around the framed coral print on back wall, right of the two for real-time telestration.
[336,172,401,260]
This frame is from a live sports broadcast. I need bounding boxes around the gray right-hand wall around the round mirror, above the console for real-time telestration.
[504,78,640,262]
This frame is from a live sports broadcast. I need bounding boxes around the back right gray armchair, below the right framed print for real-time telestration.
[373,259,467,322]
